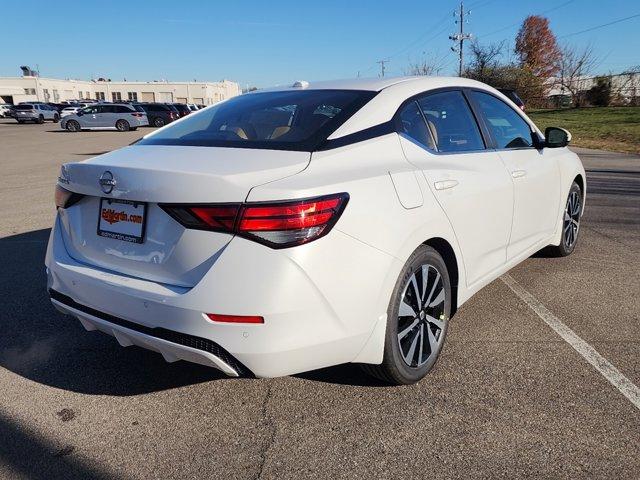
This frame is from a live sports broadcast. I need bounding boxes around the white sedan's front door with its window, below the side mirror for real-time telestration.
[470,90,560,259]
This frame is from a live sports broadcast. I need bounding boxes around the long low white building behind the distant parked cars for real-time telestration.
[0,76,241,105]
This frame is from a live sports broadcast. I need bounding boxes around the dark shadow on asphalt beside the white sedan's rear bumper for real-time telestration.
[0,229,238,396]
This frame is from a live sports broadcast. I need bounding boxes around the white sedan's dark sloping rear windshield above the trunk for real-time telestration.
[137,90,376,151]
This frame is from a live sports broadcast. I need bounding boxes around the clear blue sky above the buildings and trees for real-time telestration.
[0,0,640,87]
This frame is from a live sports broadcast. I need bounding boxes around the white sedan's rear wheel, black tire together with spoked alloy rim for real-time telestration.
[362,245,451,385]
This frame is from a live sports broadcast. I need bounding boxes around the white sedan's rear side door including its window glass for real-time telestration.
[398,90,513,285]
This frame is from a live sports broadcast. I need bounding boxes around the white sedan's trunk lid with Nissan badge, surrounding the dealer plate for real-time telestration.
[60,145,310,287]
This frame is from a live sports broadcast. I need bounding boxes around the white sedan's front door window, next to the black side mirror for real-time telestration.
[471,91,533,148]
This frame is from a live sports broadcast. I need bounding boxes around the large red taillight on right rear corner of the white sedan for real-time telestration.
[161,193,349,248]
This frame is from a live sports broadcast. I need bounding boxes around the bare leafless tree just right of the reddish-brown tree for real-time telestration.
[556,45,597,106]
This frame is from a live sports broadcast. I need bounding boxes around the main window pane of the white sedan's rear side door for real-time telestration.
[418,91,485,153]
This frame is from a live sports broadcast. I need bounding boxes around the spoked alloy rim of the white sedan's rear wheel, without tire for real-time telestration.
[398,264,447,368]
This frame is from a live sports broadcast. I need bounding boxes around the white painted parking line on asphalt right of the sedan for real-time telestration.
[500,273,640,409]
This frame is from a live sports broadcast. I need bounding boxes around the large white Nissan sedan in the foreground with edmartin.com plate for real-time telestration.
[46,77,586,384]
